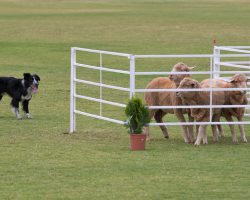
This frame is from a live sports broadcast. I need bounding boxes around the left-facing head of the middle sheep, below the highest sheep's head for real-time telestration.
[176,77,201,100]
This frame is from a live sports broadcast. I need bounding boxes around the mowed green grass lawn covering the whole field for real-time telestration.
[0,0,250,200]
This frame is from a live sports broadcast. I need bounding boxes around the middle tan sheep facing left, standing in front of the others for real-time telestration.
[176,78,225,145]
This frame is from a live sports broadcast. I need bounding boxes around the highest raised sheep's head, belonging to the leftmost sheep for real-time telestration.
[169,62,195,87]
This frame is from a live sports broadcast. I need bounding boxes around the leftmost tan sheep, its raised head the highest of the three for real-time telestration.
[144,63,195,143]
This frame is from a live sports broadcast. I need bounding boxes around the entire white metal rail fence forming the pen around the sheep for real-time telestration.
[70,46,250,132]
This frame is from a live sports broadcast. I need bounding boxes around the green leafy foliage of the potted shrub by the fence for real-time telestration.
[125,97,150,134]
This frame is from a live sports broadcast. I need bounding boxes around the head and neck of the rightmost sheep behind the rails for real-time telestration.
[230,74,250,104]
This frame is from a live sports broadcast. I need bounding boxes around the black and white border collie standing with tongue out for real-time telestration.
[0,73,40,119]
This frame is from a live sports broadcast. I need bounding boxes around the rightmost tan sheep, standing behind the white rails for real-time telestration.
[201,74,249,143]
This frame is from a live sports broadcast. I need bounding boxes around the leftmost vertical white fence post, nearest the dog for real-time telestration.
[69,47,76,133]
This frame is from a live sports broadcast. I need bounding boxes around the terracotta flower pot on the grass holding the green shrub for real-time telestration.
[130,134,146,151]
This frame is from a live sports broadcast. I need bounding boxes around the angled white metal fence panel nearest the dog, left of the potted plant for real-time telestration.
[69,47,134,133]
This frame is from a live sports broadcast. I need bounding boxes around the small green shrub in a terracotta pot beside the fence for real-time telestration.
[125,97,150,150]
